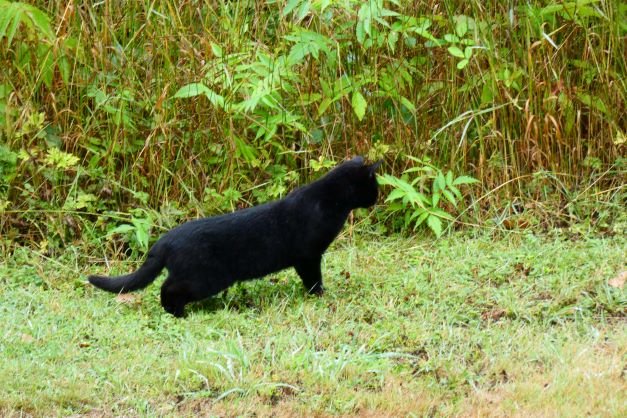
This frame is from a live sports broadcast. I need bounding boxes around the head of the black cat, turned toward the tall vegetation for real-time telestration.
[333,157,383,209]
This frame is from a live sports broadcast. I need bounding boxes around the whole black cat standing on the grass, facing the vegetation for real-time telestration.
[89,157,381,317]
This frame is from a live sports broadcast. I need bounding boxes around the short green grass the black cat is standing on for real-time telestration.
[0,233,627,417]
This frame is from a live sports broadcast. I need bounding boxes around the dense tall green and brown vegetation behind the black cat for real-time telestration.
[0,0,627,248]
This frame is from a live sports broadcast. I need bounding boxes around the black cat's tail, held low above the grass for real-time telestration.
[88,243,165,293]
